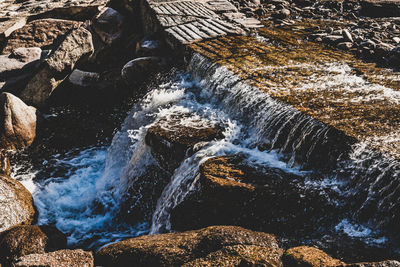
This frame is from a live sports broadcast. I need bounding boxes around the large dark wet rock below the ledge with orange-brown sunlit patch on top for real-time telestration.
[171,156,335,234]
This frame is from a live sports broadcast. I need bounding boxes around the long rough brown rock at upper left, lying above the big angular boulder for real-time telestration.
[3,19,82,53]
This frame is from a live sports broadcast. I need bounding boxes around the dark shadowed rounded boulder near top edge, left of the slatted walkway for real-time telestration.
[92,7,124,45]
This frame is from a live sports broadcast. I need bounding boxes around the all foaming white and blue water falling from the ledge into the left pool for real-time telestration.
[10,52,400,258]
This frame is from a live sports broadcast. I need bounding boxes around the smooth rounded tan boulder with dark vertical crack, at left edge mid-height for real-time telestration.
[0,93,38,150]
